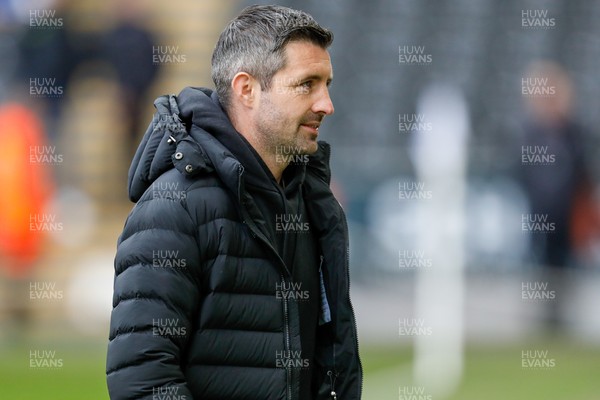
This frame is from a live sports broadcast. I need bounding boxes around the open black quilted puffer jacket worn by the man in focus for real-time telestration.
[107,88,362,400]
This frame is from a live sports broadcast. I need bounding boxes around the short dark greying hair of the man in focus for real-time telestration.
[212,5,333,109]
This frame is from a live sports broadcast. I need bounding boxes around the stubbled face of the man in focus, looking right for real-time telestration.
[255,41,334,154]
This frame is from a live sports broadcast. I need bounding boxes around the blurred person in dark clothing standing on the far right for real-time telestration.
[519,61,597,326]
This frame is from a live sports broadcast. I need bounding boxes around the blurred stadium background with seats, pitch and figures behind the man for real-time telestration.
[0,0,600,400]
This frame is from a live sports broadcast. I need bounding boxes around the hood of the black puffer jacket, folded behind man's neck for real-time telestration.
[128,87,328,202]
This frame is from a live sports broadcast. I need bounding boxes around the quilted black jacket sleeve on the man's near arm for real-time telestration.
[106,190,200,400]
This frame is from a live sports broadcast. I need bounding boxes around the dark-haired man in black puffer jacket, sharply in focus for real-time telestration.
[107,6,362,400]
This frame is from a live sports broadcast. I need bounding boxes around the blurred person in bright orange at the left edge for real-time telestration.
[0,102,53,331]
